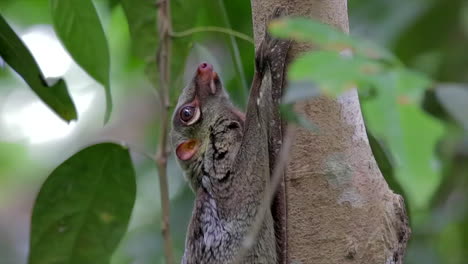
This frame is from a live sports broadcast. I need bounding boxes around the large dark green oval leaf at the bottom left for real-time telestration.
[29,143,136,264]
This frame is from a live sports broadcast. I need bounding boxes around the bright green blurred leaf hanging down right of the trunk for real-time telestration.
[362,72,443,209]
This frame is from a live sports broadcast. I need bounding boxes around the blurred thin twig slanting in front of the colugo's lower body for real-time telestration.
[233,125,296,264]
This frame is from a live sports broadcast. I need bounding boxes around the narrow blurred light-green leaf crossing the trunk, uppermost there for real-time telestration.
[269,17,401,65]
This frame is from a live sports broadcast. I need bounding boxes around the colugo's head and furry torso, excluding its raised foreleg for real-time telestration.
[171,63,276,264]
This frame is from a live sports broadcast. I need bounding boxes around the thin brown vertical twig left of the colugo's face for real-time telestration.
[156,0,174,264]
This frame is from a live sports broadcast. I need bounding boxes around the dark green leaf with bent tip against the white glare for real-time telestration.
[0,15,77,121]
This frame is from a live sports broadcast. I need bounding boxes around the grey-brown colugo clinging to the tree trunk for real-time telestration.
[171,8,289,264]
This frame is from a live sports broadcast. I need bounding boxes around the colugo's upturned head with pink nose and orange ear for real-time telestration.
[171,62,244,190]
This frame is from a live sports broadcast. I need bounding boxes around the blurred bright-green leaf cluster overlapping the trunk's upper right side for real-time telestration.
[270,18,441,208]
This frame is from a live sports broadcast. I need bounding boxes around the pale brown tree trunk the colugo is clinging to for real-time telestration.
[252,0,410,264]
